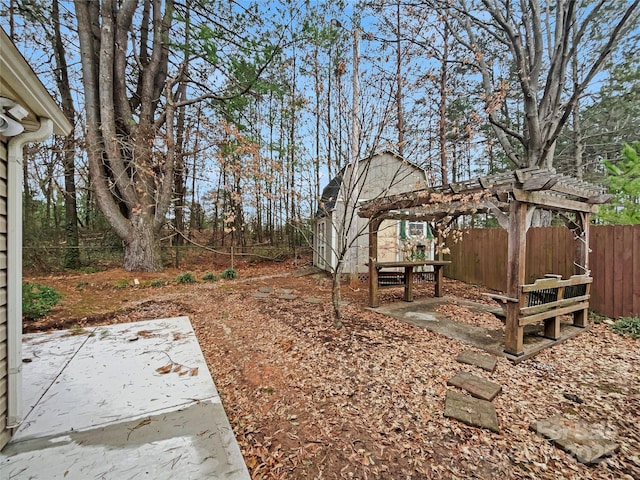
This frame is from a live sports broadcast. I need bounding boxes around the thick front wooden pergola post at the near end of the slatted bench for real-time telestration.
[504,200,527,356]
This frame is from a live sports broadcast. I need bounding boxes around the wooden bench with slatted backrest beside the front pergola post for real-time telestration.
[485,275,593,354]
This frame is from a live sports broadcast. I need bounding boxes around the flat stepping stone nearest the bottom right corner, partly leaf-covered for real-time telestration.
[529,415,619,464]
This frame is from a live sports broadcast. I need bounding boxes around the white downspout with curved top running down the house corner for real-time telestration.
[6,118,53,429]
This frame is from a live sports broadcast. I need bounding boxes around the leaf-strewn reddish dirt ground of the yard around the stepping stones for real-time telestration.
[25,260,640,479]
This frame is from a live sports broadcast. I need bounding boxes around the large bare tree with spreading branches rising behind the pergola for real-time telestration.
[436,0,640,171]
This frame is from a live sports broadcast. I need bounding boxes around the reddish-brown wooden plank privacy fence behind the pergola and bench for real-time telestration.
[444,225,640,318]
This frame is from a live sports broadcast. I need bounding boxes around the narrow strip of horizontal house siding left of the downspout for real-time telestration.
[0,141,10,449]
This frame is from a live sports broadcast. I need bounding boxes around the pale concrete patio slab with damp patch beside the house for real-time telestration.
[0,317,249,480]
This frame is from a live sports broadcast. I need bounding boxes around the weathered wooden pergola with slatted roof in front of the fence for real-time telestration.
[358,168,611,355]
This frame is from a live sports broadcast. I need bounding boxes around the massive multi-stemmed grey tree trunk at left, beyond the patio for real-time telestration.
[75,0,174,271]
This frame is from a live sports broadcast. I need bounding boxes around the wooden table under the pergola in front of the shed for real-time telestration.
[368,259,451,308]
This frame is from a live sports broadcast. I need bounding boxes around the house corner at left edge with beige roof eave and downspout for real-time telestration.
[0,28,73,448]
